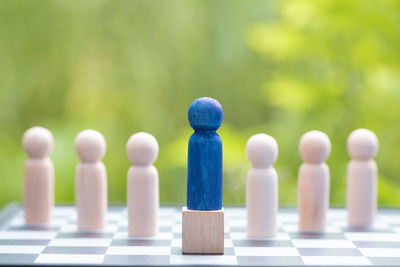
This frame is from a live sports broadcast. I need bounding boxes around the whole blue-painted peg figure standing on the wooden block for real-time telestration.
[187,97,224,210]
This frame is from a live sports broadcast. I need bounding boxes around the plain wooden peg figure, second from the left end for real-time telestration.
[75,130,107,230]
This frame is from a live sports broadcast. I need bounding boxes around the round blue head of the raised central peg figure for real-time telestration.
[188,97,224,131]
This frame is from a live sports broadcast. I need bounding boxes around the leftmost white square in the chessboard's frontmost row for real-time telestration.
[35,254,104,264]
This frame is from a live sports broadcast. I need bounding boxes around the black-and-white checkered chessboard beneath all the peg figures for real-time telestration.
[0,205,400,266]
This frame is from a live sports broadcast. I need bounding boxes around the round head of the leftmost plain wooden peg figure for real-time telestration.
[22,126,54,159]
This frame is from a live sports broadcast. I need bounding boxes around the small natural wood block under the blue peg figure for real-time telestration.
[182,207,224,254]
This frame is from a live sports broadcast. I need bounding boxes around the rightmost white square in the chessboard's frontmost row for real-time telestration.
[301,256,372,266]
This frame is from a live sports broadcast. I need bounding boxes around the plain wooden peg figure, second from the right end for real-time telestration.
[298,131,331,232]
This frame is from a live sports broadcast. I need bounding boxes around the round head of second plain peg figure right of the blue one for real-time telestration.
[299,131,331,163]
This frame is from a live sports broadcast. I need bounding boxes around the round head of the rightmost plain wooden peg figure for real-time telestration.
[347,129,378,160]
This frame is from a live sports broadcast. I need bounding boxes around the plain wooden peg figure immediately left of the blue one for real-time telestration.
[126,132,159,237]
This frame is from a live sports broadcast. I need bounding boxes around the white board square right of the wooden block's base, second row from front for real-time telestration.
[235,247,300,257]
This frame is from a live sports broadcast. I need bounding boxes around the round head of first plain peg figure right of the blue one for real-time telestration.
[246,133,278,168]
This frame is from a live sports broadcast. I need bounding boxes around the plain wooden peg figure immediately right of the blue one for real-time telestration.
[246,134,278,237]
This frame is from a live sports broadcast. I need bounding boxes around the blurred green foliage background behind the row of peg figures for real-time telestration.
[0,0,400,209]
